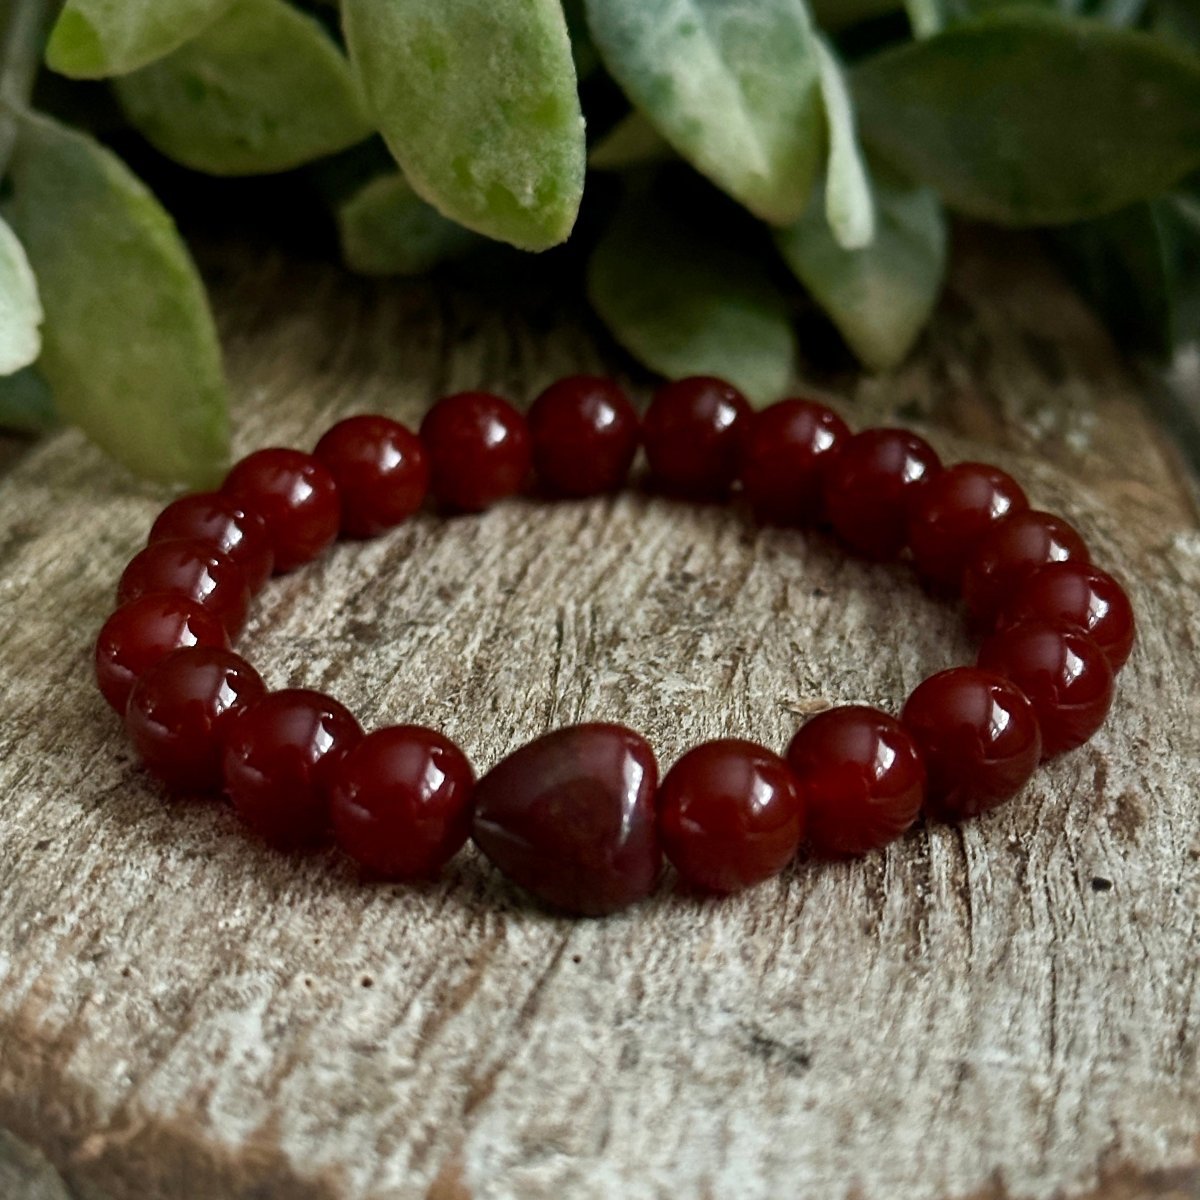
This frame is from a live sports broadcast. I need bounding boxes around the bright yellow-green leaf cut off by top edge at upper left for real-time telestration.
[46,0,230,79]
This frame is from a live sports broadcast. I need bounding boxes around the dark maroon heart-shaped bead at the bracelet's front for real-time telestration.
[472,725,661,917]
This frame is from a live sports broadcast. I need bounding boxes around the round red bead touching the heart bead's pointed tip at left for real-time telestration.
[329,725,475,880]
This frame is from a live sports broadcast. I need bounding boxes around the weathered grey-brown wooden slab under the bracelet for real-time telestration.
[0,226,1200,1200]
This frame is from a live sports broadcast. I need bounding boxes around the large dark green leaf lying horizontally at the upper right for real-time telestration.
[853,8,1200,226]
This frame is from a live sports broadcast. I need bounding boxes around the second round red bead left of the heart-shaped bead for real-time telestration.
[222,688,362,848]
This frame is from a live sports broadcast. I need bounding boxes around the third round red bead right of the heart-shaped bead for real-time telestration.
[900,667,1042,821]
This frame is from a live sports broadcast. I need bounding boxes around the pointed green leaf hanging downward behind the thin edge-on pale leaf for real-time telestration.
[776,170,946,371]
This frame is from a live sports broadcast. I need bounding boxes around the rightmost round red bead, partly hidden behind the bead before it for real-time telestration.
[997,562,1136,673]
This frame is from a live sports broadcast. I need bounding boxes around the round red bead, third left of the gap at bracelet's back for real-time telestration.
[313,416,430,538]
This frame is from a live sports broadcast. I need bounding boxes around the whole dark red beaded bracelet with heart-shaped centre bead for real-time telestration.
[96,376,1134,914]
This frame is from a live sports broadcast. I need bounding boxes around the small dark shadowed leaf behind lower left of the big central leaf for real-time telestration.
[337,172,480,275]
